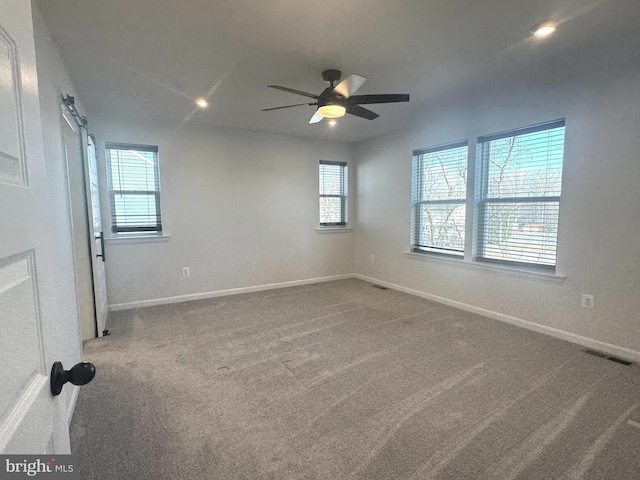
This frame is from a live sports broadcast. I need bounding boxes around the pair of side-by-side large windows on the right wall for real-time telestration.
[411,120,565,270]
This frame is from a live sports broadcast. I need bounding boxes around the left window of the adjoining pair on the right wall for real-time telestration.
[411,141,468,256]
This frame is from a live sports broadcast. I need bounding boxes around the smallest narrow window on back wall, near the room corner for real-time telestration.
[319,160,349,227]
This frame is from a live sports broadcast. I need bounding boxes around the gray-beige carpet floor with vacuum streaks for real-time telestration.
[71,279,640,480]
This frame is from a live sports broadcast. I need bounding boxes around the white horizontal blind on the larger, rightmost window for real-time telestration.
[474,120,565,269]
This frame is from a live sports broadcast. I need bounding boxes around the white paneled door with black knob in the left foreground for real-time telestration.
[0,0,80,454]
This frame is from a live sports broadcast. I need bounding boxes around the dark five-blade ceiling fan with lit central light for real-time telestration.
[262,69,409,123]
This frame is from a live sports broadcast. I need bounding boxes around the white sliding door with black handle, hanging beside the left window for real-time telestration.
[85,135,109,337]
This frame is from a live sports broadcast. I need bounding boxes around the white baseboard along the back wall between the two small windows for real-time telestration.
[109,273,354,312]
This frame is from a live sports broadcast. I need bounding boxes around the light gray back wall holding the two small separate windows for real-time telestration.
[91,118,355,308]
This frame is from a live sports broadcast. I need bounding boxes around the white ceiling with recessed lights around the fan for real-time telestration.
[37,0,640,141]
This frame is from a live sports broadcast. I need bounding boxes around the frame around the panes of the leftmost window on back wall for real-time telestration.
[105,142,162,238]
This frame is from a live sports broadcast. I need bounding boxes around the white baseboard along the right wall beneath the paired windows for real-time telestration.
[353,274,640,362]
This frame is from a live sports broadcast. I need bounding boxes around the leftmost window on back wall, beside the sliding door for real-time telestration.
[106,143,162,235]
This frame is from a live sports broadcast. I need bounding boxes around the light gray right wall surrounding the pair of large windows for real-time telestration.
[355,66,640,358]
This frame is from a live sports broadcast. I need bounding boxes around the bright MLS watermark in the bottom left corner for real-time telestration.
[0,455,80,480]
